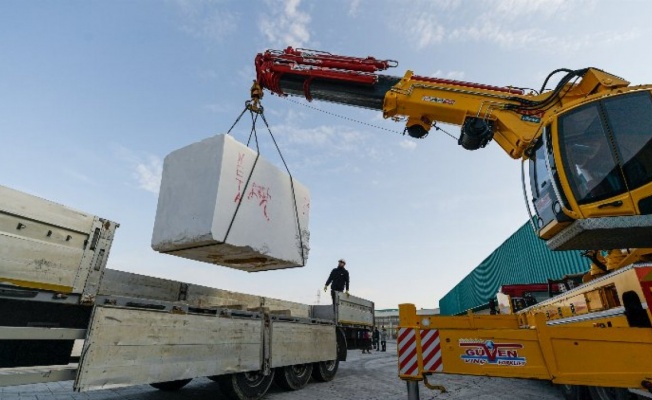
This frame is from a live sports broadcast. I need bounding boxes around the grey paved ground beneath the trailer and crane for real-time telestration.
[0,342,563,400]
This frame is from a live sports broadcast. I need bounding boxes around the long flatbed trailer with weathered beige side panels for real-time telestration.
[0,186,374,399]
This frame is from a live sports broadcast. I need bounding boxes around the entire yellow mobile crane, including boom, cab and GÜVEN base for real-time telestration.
[250,47,652,400]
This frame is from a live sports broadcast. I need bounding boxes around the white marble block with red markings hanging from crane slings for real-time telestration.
[152,135,310,272]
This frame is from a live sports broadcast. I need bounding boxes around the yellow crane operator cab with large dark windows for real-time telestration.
[526,90,652,250]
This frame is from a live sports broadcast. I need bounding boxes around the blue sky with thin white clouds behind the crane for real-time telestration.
[0,0,652,308]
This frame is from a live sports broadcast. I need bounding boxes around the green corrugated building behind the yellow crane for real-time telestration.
[439,222,590,315]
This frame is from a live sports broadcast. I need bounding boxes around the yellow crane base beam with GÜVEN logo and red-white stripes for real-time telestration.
[397,296,652,390]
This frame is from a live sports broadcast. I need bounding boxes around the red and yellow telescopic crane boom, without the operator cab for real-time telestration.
[255,47,629,158]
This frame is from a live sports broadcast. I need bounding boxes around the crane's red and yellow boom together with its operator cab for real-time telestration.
[255,47,652,260]
